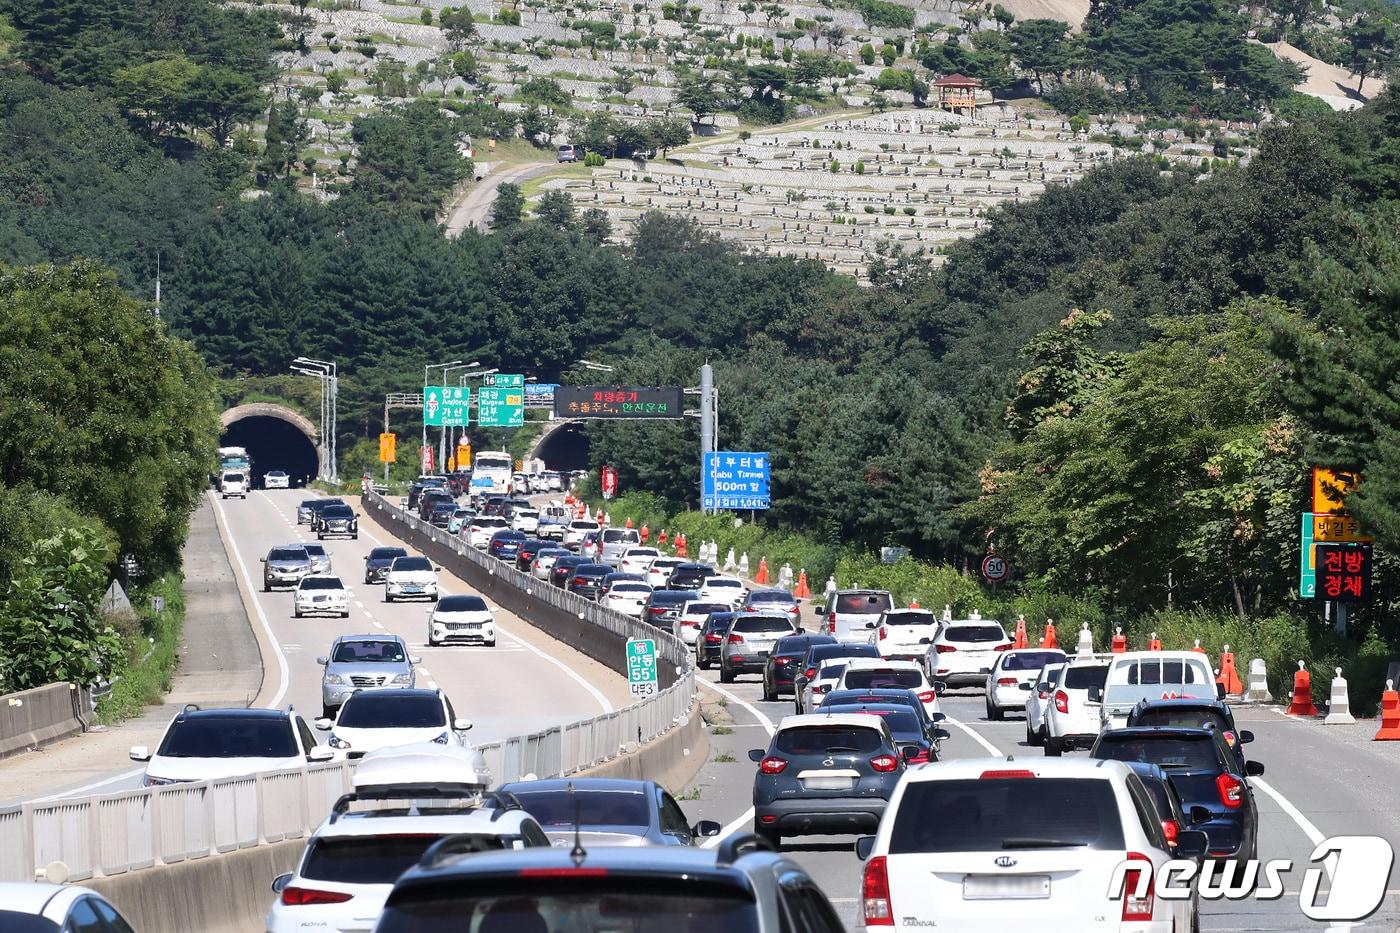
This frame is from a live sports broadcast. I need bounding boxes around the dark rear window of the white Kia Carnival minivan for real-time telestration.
[889,778,1124,855]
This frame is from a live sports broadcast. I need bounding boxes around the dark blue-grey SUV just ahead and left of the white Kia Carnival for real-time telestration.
[749,712,914,846]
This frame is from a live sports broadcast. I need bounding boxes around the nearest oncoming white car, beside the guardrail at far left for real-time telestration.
[130,703,335,787]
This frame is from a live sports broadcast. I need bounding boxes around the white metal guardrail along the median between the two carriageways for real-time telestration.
[0,495,694,881]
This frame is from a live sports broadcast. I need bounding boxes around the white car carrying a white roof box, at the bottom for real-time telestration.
[265,745,549,933]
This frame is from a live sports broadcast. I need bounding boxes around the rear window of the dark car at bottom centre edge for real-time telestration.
[375,876,759,933]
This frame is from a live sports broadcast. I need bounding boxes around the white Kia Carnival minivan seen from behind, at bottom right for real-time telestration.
[855,758,1207,933]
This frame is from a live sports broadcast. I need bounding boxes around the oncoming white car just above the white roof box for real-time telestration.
[316,686,472,761]
